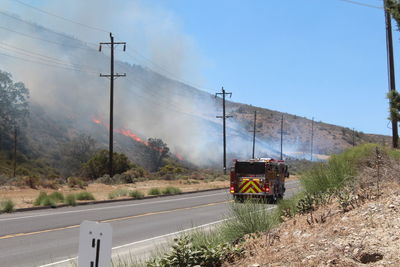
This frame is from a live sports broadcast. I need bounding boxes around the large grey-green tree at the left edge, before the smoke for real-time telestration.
[0,70,29,150]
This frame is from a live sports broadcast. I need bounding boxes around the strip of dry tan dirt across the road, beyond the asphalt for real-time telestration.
[0,180,229,209]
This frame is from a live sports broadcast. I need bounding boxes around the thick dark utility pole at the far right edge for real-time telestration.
[383,0,399,148]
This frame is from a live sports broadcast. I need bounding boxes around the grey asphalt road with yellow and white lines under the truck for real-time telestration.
[0,181,298,267]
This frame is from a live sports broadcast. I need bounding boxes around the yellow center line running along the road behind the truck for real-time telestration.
[0,200,232,240]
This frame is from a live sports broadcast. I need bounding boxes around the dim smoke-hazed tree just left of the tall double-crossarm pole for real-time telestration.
[61,134,96,176]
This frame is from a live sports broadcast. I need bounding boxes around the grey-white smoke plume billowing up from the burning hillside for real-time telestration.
[0,0,320,168]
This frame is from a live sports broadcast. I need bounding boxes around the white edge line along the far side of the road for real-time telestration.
[0,192,228,222]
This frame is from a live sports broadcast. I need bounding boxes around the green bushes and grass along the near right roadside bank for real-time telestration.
[136,144,400,267]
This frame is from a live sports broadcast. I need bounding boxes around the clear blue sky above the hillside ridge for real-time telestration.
[9,0,400,134]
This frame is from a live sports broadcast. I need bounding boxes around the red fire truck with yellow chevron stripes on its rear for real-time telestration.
[230,158,289,203]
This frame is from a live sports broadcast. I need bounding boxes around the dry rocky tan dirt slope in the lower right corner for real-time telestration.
[229,183,400,266]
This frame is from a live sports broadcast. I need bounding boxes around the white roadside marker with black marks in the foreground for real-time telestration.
[78,221,112,267]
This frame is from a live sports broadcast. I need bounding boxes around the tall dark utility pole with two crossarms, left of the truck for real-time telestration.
[99,32,126,177]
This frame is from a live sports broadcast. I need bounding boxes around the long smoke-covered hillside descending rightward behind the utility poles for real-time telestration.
[0,11,390,176]
